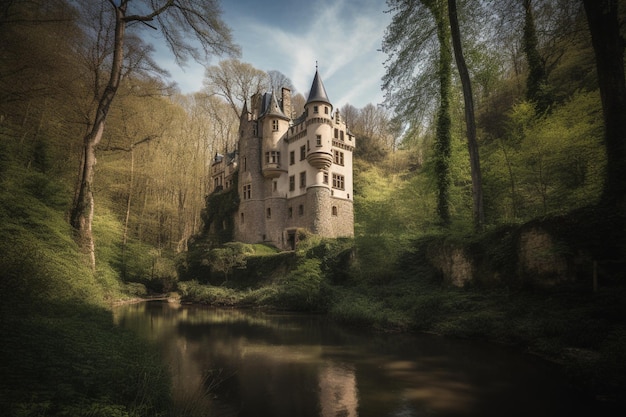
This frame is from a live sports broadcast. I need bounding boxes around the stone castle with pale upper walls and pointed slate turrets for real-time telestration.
[211,69,355,250]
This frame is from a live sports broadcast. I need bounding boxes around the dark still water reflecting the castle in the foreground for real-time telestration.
[115,302,598,417]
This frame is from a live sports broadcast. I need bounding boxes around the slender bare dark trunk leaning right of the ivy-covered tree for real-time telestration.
[448,0,485,232]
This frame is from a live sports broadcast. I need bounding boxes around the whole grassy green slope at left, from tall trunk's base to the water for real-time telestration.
[0,162,170,417]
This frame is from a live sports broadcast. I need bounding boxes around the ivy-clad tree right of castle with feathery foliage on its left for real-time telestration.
[382,0,452,226]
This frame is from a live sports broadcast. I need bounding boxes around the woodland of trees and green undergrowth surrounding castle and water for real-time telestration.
[0,0,626,416]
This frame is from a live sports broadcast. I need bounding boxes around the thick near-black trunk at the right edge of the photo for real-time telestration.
[583,0,626,208]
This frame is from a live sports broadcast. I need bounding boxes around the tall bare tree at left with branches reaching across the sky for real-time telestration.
[70,0,238,268]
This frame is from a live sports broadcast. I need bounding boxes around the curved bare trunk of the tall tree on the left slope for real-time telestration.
[70,3,126,270]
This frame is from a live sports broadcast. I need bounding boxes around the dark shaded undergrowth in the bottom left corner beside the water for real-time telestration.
[0,303,170,416]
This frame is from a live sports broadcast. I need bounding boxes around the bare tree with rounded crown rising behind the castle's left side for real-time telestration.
[204,59,270,119]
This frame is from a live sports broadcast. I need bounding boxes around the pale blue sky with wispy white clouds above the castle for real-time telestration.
[155,0,391,108]
